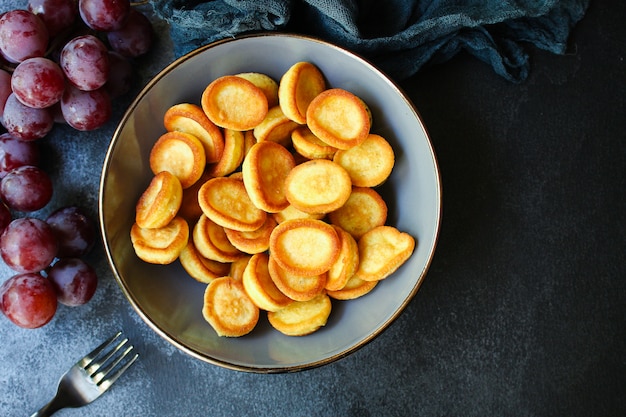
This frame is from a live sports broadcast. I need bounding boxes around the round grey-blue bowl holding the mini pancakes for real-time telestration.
[99,34,441,373]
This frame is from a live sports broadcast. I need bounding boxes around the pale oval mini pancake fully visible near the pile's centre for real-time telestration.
[285,159,352,213]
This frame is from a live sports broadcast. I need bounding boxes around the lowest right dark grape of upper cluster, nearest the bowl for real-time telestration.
[61,86,112,130]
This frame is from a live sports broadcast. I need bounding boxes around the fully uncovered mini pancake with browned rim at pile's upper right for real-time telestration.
[306,88,371,149]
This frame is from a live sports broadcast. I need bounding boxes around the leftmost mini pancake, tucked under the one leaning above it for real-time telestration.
[130,217,189,265]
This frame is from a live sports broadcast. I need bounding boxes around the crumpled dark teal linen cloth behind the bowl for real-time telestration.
[152,0,590,82]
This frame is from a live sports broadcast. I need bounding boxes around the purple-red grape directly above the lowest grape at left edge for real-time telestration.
[0,217,58,273]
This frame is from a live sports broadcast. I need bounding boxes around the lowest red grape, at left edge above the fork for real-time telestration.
[0,273,58,329]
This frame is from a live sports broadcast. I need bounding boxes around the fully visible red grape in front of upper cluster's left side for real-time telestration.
[11,57,65,109]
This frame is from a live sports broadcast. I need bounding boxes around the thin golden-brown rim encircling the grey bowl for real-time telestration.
[98,32,443,374]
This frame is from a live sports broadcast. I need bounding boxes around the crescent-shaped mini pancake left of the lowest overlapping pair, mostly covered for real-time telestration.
[242,253,292,311]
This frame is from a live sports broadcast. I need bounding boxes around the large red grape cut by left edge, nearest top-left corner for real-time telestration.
[0,10,49,64]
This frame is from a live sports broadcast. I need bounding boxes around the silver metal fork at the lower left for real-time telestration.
[31,332,139,417]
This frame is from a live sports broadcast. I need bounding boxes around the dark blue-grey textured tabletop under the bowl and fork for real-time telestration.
[0,0,626,417]
